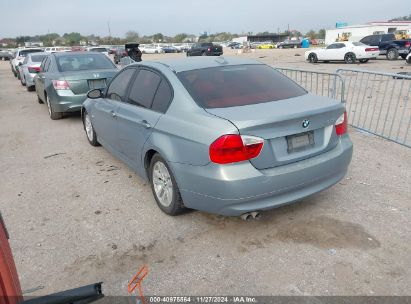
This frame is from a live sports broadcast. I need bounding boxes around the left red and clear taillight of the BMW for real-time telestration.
[209,134,264,164]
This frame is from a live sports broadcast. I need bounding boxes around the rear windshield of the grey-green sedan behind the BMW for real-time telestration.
[57,53,116,72]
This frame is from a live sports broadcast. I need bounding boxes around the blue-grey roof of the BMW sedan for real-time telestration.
[137,56,263,73]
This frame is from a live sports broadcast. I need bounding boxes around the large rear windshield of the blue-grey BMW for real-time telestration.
[177,64,307,108]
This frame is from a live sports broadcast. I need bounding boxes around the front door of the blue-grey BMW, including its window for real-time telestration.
[90,67,136,152]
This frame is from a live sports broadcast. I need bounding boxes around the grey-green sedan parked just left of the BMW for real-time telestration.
[34,52,118,119]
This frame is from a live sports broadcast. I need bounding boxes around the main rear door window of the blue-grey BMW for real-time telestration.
[129,70,161,109]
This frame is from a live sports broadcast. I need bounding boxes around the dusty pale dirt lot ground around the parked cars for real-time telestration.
[0,50,411,295]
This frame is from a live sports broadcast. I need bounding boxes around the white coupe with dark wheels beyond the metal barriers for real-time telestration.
[305,41,380,63]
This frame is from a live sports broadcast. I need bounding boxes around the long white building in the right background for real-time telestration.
[325,21,411,44]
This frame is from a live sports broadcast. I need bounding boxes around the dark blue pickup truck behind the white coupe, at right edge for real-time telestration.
[360,34,411,60]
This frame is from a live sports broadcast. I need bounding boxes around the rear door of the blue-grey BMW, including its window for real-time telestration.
[118,68,171,173]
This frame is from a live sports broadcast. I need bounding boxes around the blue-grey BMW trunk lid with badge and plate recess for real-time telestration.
[205,94,345,170]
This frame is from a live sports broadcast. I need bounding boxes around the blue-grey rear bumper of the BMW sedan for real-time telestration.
[170,135,353,216]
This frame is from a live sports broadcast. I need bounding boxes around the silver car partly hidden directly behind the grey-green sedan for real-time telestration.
[18,52,49,91]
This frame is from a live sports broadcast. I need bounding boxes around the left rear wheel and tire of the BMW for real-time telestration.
[149,154,186,215]
